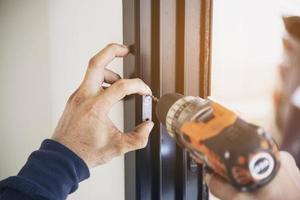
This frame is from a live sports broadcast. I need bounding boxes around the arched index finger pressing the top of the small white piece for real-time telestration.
[98,78,152,111]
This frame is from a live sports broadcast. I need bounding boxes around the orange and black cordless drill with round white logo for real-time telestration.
[156,93,280,191]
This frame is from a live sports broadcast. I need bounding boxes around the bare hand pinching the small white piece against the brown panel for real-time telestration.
[52,44,153,167]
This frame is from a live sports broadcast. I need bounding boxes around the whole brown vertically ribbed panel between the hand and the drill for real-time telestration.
[123,0,212,200]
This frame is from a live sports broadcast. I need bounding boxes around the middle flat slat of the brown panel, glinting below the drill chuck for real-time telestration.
[158,0,176,199]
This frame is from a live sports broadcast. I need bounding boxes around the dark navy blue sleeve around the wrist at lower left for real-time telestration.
[0,139,90,200]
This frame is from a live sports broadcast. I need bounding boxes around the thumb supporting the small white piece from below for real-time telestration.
[123,121,154,153]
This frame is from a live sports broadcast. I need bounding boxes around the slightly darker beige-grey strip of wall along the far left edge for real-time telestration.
[0,1,52,179]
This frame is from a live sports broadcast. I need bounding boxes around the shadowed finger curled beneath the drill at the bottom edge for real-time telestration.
[205,173,238,200]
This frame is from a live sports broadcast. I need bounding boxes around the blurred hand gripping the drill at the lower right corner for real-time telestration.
[205,152,300,200]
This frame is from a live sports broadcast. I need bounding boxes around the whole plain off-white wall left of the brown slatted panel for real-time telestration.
[0,0,124,200]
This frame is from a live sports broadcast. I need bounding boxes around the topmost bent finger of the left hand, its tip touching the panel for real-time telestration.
[81,44,129,94]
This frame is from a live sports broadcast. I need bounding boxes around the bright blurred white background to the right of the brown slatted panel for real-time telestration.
[211,0,300,143]
